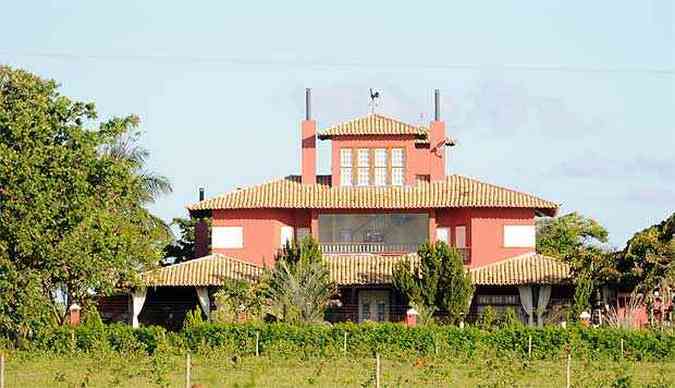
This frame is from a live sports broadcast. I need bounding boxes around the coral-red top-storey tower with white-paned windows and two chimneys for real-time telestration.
[301,89,453,187]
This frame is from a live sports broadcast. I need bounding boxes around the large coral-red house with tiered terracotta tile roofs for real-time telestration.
[104,89,570,324]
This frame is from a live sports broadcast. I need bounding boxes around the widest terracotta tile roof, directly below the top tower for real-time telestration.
[188,175,558,215]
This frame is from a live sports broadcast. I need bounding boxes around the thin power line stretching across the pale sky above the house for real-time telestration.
[0,51,675,76]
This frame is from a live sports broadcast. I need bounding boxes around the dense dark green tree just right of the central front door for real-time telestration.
[393,241,474,323]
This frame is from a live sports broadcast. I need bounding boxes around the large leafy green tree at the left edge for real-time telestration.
[0,67,168,338]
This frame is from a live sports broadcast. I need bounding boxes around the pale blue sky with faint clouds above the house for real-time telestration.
[0,0,675,247]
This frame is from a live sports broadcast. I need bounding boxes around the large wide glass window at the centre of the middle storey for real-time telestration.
[319,213,429,247]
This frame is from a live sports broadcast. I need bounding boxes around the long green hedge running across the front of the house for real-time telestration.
[18,323,675,360]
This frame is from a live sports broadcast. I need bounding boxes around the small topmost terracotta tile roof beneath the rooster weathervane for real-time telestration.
[319,114,428,139]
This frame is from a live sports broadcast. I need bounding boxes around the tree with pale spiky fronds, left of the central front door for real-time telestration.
[263,237,336,323]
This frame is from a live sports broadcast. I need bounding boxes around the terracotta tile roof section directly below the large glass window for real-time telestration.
[324,254,419,285]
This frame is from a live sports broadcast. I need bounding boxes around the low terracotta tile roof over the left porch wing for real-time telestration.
[141,254,262,286]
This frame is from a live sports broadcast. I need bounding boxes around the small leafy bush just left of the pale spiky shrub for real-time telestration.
[211,280,266,323]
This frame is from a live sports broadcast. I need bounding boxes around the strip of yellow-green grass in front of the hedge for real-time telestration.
[5,351,675,387]
